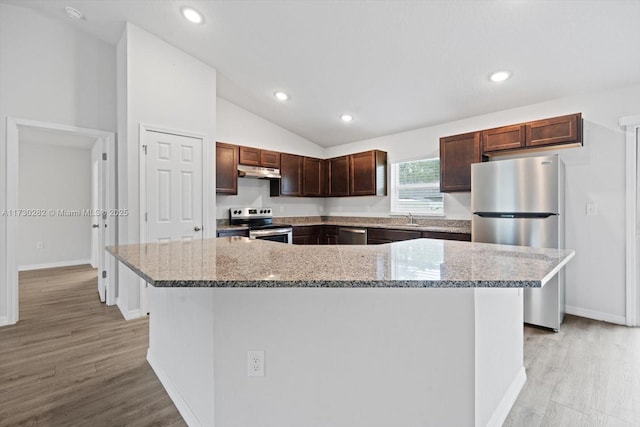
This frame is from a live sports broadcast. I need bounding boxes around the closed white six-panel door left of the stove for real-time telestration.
[143,130,203,242]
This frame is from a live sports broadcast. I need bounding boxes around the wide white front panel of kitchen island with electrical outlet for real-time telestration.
[213,288,475,427]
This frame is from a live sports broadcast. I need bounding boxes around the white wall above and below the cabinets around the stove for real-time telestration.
[216,98,325,218]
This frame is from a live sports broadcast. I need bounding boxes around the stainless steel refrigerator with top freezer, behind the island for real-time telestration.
[471,155,565,331]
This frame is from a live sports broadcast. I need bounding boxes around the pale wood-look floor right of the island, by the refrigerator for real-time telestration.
[504,316,640,427]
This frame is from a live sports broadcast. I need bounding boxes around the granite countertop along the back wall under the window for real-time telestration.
[216,216,471,234]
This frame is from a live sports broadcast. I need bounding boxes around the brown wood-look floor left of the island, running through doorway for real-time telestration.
[0,266,185,427]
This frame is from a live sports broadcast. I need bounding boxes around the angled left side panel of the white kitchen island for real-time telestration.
[147,287,214,427]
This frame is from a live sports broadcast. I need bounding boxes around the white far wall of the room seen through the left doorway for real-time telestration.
[16,142,91,270]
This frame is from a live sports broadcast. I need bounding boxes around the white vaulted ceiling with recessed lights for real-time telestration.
[5,0,640,146]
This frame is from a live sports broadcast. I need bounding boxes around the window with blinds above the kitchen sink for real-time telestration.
[391,158,444,215]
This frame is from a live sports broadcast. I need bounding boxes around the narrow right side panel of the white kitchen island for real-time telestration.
[474,288,526,427]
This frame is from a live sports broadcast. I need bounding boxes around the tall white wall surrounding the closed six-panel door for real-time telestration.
[117,23,216,318]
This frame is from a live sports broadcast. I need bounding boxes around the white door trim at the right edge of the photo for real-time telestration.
[616,115,640,326]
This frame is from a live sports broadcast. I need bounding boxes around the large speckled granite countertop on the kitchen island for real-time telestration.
[107,237,574,288]
